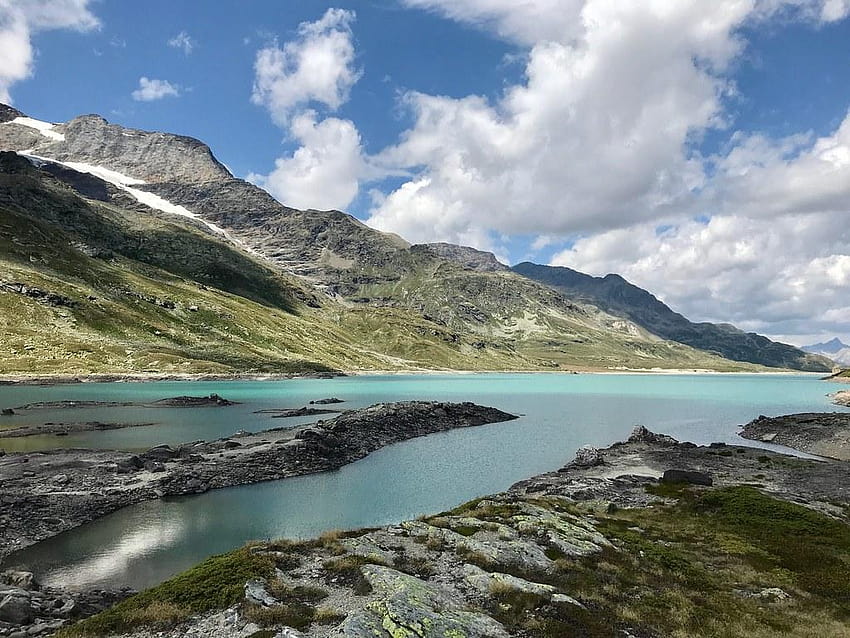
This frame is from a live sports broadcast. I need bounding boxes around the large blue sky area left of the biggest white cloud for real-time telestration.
[14,0,522,190]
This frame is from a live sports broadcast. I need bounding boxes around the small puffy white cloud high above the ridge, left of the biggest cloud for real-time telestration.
[251,9,360,126]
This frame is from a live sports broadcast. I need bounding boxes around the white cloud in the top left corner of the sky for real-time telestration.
[0,0,100,103]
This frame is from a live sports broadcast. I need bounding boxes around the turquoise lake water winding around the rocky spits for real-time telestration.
[0,374,842,587]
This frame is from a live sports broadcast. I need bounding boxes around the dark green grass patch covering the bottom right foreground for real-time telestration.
[564,485,850,638]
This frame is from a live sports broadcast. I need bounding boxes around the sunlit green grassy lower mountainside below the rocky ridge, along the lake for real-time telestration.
[0,153,756,373]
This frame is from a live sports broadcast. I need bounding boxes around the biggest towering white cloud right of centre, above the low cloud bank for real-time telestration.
[371,0,747,241]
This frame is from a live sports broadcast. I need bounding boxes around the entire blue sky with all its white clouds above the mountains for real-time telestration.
[0,0,850,345]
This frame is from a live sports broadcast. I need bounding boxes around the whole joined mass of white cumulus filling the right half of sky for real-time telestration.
[360,0,850,344]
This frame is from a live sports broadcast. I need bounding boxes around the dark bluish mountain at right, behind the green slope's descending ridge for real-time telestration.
[513,262,832,372]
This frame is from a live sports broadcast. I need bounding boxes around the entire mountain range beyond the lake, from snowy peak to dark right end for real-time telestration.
[0,105,830,373]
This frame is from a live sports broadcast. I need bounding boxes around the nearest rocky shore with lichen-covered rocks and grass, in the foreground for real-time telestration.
[9,428,850,638]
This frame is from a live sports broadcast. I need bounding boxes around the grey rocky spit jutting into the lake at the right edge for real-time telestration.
[739,412,850,461]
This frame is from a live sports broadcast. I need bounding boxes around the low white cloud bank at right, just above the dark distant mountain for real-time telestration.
[552,213,850,342]
